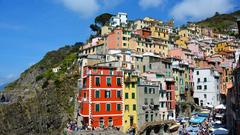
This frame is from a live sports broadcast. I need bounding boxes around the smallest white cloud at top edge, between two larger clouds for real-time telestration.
[138,0,163,9]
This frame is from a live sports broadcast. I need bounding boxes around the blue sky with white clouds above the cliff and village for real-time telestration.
[0,0,240,85]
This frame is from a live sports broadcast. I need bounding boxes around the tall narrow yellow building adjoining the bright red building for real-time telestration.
[122,70,138,133]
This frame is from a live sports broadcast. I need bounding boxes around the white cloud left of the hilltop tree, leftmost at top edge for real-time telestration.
[62,0,99,18]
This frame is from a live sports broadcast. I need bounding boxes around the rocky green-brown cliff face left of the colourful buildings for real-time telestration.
[0,45,79,135]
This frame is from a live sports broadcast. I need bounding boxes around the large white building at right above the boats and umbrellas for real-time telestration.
[193,68,220,107]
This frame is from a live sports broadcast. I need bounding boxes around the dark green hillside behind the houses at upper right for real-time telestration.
[197,10,240,34]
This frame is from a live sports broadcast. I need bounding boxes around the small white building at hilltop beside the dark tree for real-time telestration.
[110,12,128,27]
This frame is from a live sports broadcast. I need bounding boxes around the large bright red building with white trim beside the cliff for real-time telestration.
[79,66,123,128]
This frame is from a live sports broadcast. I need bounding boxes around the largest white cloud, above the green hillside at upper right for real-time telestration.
[170,0,234,21]
